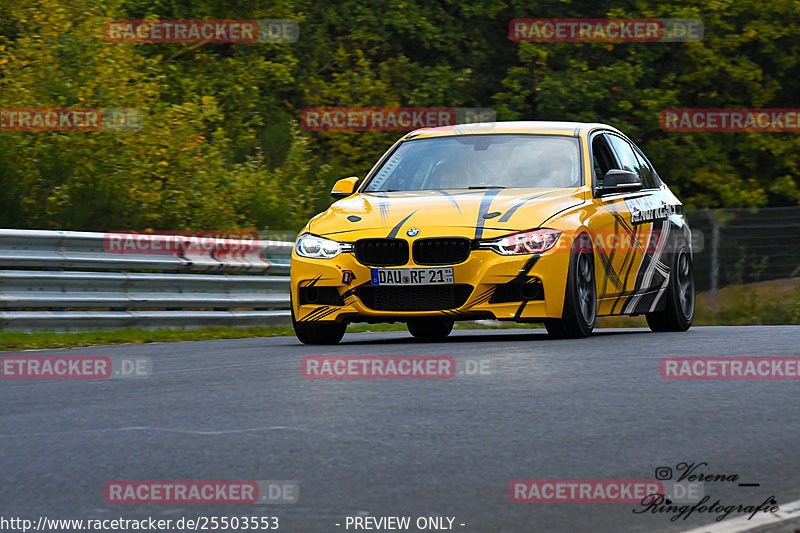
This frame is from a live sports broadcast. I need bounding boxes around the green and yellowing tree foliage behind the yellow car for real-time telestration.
[0,0,800,230]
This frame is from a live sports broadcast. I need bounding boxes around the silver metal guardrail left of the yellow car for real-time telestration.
[0,229,292,331]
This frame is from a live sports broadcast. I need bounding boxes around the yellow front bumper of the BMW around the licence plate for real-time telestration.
[291,239,570,322]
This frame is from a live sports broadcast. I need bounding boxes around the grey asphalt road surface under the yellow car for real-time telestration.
[0,326,800,532]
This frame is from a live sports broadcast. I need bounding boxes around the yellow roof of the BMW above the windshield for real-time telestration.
[403,121,621,140]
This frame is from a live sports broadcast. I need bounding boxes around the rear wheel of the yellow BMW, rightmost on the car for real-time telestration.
[645,242,695,331]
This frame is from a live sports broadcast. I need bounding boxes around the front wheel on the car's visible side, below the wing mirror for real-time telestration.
[544,234,597,339]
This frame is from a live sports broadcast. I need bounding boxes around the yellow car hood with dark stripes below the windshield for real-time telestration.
[308,188,584,241]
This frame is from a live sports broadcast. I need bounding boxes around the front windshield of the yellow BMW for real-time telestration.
[364,134,581,192]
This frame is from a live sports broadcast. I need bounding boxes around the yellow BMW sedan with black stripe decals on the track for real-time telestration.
[291,122,695,344]
